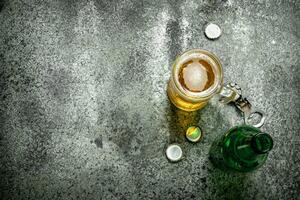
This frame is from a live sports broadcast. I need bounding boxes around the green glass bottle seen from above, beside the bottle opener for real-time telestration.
[209,125,273,172]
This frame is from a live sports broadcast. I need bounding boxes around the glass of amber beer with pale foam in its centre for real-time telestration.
[167,49,223,111]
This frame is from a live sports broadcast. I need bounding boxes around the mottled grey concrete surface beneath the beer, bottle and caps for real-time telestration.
[0,0,300,200]
